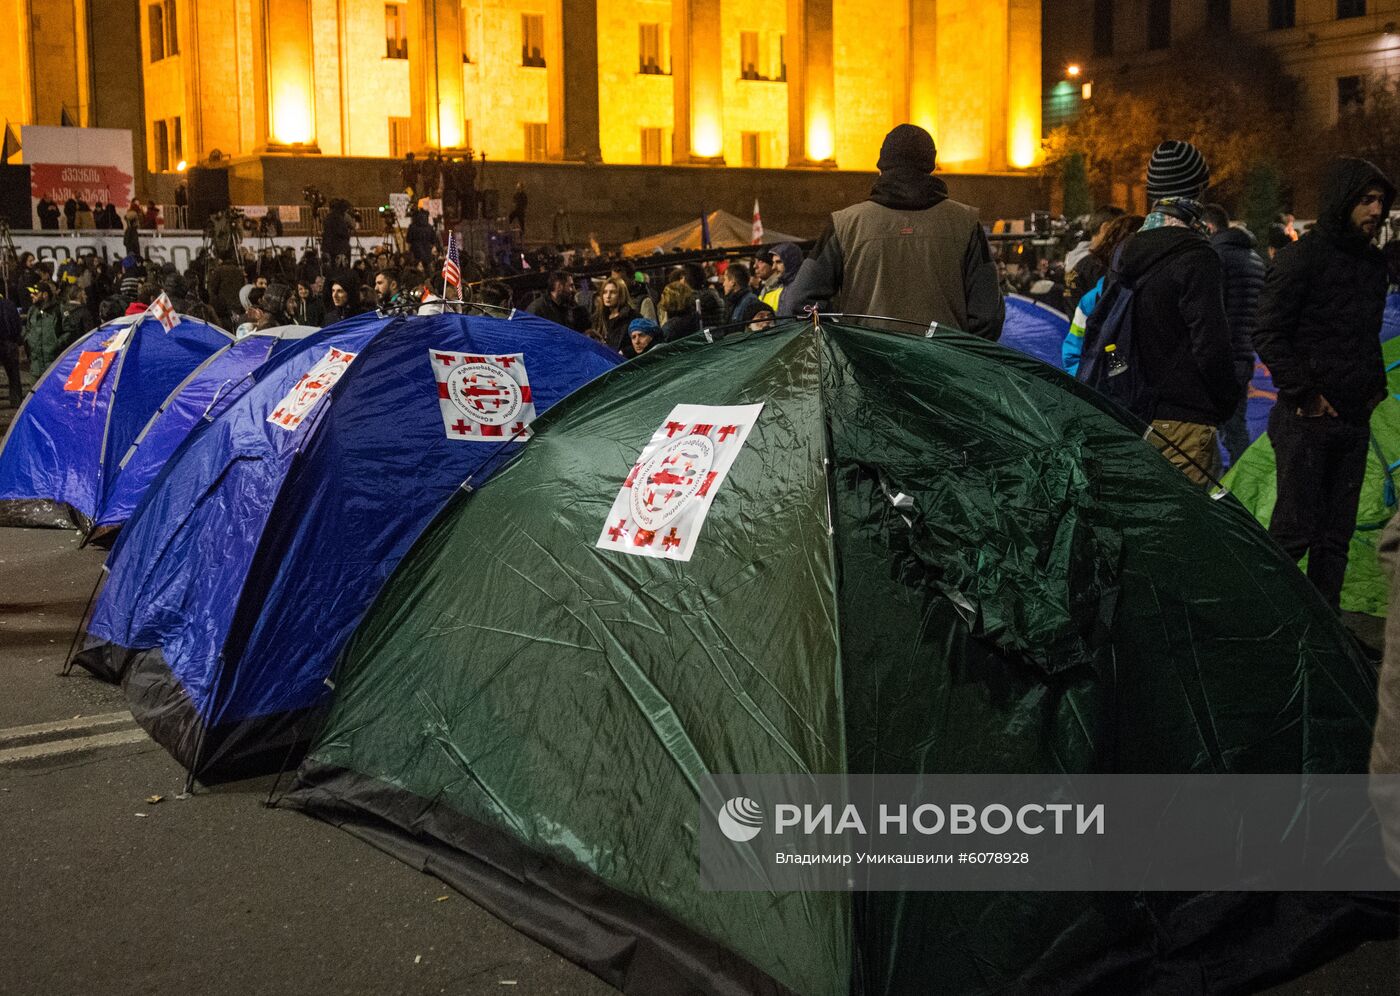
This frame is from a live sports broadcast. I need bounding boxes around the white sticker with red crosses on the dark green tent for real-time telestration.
[596,405,763,560]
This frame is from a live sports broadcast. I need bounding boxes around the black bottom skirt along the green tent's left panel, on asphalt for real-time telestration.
[277,763,790,993]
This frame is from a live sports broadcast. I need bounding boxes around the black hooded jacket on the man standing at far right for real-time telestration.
[1254,160,1394,426]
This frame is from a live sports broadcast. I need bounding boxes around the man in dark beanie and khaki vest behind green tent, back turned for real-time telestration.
[784,125,1007,339]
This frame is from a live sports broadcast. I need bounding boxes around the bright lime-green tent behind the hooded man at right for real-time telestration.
[1222,339,1400,618]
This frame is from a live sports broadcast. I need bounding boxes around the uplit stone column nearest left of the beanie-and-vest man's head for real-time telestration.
[787,0,836,167]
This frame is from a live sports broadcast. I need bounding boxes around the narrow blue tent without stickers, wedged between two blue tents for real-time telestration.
[92,325,318,535]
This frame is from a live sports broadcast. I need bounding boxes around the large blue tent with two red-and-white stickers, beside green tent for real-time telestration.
[77,312,620,782]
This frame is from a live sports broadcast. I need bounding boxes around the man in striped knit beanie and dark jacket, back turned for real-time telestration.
[1081,141,1240,483]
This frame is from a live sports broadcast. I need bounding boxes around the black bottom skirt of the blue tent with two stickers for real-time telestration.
[73,642,319,784]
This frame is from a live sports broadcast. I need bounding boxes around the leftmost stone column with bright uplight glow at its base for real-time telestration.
[253,0,321,153]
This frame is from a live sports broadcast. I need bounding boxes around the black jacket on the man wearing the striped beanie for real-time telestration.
[1085,226,1242,426]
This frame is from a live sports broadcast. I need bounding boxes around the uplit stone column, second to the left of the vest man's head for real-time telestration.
[671,0,724,165]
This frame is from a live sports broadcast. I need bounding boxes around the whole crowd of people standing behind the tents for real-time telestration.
[8,125,1396,627]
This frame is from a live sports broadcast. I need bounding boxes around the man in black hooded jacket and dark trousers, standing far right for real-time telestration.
[1254,160,1396,608]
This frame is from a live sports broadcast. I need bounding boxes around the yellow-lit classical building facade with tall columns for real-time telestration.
[0,0,1040,172]
